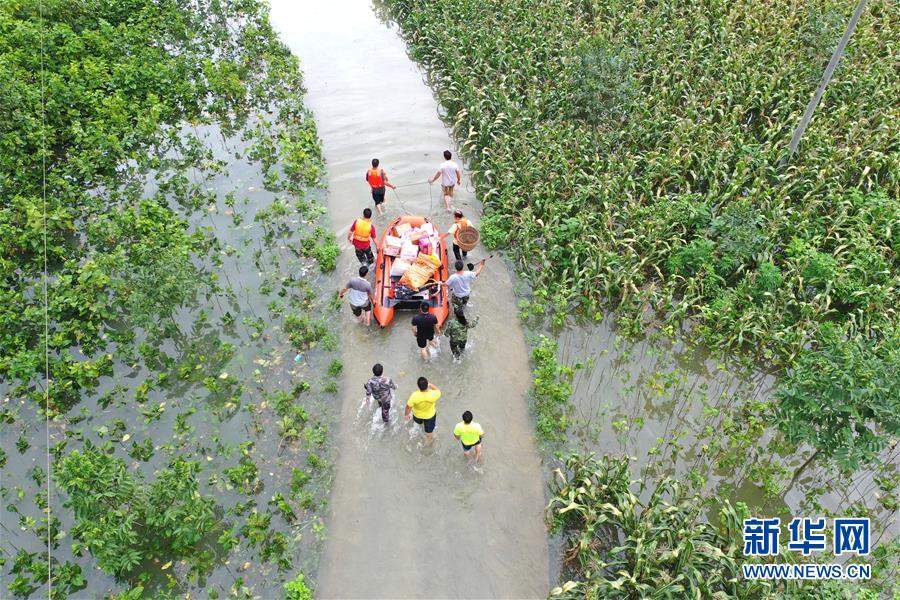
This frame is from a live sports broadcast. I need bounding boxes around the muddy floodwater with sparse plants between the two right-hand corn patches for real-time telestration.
[557,316,897,539]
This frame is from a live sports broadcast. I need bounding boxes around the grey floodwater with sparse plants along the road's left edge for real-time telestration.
[3,119,340,597]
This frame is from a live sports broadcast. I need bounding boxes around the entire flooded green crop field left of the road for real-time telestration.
[0,0,337,598]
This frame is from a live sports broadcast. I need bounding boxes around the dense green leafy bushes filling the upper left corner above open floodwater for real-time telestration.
[0,0,301,412]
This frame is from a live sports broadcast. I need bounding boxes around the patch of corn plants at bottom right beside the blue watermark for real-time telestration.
[547,455,897,600]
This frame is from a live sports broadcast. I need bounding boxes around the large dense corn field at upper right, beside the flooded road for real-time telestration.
[385,0,900,463]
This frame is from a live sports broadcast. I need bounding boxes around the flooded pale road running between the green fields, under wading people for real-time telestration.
[271,0,549,598]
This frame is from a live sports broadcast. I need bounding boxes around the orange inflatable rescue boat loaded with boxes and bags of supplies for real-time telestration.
[373,215,450,327]
